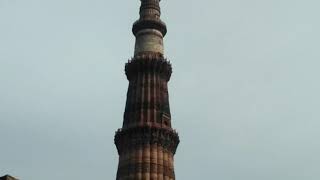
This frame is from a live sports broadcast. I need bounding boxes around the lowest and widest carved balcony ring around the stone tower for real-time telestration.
[114,126,180,155]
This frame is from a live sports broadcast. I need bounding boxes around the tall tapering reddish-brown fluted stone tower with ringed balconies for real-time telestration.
[114,0,179,180]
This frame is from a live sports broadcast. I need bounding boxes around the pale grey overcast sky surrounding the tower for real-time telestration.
[0,0,320,180]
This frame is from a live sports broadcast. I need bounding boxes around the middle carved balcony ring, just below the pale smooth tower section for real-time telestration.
[125,53,172,81]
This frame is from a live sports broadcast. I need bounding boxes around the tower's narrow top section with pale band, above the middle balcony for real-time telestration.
[132,0,167,56]
